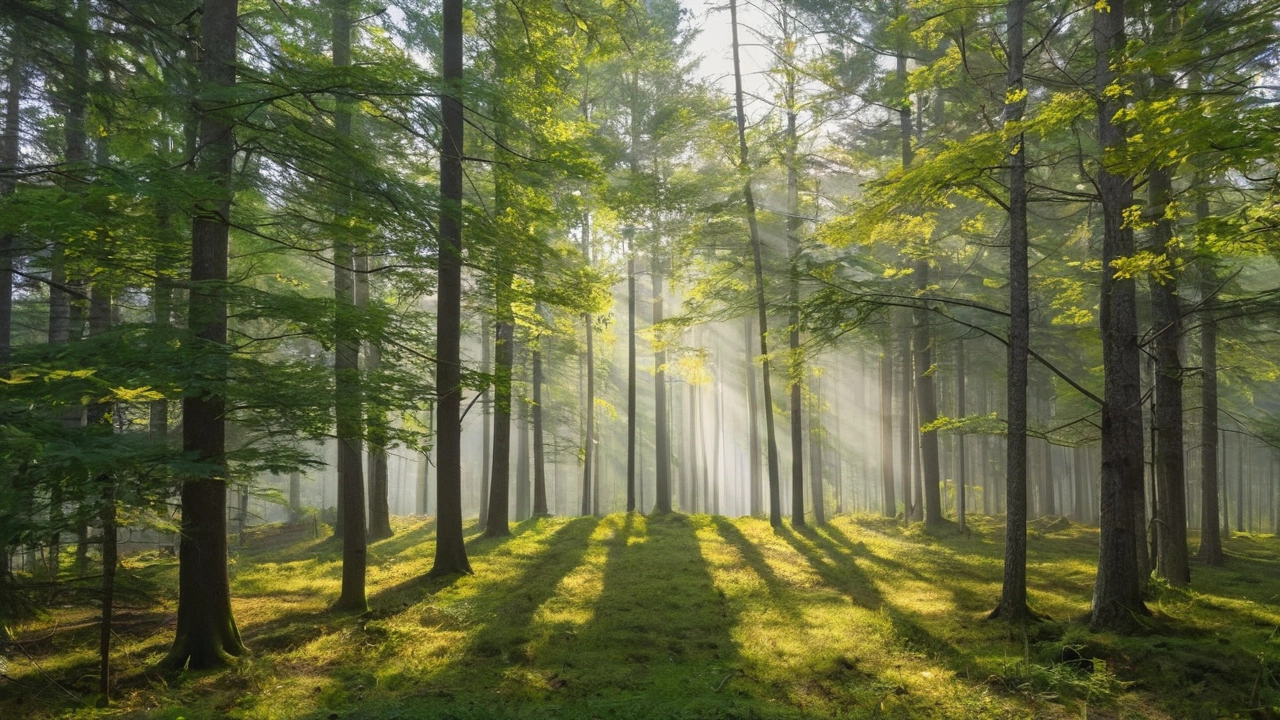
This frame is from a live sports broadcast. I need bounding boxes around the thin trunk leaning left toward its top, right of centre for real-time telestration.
[728,0,782,520]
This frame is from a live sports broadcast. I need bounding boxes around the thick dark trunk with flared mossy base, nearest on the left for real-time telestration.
[163,0,244,670]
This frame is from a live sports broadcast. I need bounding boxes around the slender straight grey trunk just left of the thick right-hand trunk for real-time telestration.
[991,0,1032,623]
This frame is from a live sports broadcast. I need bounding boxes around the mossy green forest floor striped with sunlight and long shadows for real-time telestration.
[0,515,1280,720]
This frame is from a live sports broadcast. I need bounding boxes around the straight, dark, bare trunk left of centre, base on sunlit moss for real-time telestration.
[429,0,471,577]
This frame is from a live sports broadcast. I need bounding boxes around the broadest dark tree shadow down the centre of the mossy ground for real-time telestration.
[536,514,746,717]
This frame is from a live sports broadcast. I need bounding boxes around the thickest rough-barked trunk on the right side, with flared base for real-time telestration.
[1092,0,1146,630]
